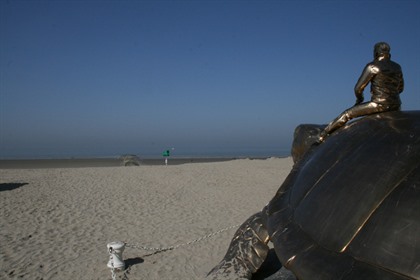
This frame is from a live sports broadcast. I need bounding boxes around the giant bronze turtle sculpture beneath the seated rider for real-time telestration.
[207,111,420,280]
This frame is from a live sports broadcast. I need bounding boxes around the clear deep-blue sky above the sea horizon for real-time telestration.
[0,0,420,158]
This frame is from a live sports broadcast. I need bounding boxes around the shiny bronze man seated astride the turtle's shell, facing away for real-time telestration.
[318,42,404,143]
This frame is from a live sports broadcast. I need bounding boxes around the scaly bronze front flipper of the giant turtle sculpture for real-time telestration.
[207,212,269,280]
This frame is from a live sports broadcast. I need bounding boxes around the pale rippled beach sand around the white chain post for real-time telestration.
[0,158,293,280]
